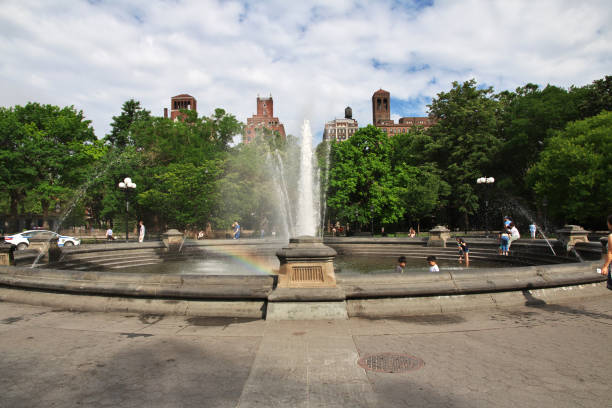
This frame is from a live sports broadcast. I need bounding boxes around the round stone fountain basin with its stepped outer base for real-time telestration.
[0,238,605,318]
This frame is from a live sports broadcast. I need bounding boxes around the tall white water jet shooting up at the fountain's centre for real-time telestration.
[296,120,318,236]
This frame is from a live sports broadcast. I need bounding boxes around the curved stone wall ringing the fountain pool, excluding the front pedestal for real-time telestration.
[0,238,604,317]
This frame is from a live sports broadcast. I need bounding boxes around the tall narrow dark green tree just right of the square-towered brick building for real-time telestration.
[425,79,501,229]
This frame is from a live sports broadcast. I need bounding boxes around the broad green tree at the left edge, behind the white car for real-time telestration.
[0,102,103,230]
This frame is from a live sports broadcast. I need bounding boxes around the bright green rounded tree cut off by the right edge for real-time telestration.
[528,111,612,226]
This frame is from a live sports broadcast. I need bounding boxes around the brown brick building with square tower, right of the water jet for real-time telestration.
[372,89,435,135]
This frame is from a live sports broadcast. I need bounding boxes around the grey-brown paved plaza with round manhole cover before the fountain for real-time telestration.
[0,296,612,408]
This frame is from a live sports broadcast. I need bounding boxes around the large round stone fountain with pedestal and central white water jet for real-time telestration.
[0,122,602,319]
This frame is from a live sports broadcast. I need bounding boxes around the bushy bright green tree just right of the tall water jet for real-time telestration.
[327,126,448,224]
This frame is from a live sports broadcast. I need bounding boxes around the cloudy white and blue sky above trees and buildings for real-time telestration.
[0,0,612,141]
